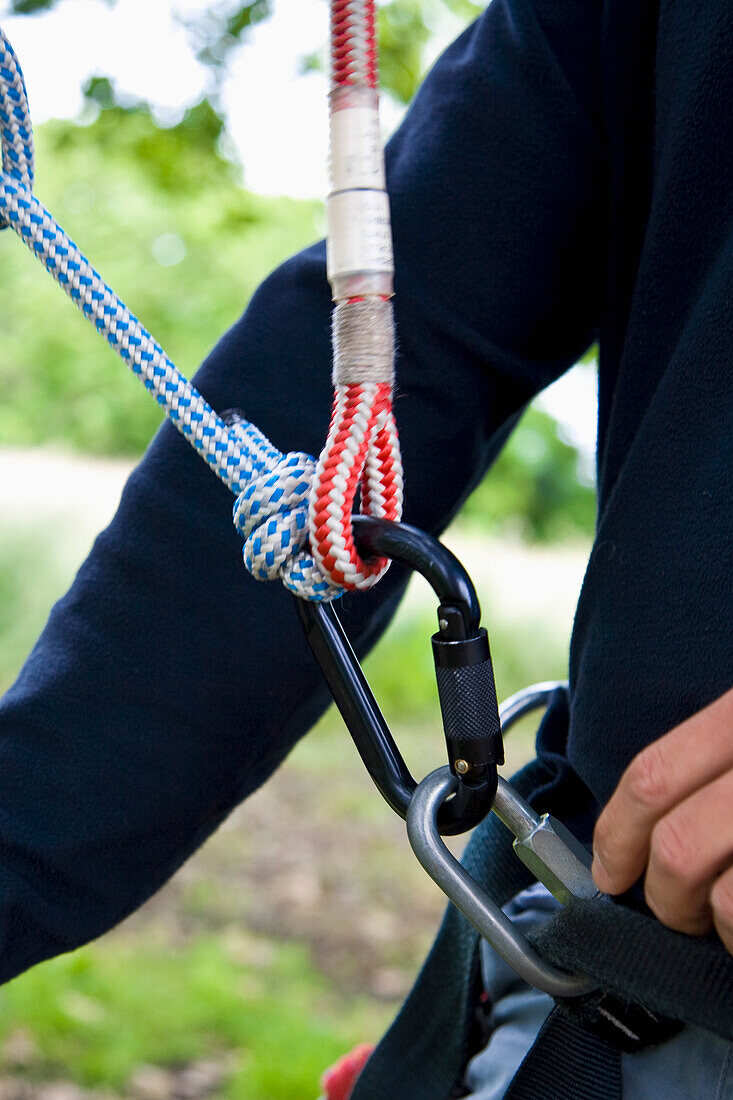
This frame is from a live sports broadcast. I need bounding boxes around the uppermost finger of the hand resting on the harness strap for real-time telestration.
[593,691,733,893]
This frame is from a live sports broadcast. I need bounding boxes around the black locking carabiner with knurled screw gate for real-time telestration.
[295,516,504,836]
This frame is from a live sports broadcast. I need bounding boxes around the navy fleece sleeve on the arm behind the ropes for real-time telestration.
[0,0,604,980]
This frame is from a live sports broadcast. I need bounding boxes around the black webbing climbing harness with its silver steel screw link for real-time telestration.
[348,668,733,1100]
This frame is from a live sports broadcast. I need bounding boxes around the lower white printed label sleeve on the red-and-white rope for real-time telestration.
[326,191,394,281]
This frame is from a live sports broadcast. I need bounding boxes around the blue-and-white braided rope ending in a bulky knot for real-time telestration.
[0,30,340,602]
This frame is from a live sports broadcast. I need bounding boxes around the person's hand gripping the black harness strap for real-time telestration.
[593,690,733,954]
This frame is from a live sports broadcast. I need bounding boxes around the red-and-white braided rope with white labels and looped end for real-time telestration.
[308,0,403,589]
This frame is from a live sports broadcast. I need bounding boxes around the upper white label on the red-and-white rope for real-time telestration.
[330,105,384,191]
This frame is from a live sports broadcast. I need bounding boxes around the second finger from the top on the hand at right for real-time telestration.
[644,769,733,936]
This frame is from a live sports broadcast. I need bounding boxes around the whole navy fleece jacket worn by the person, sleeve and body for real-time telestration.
[0,0,733,979]
